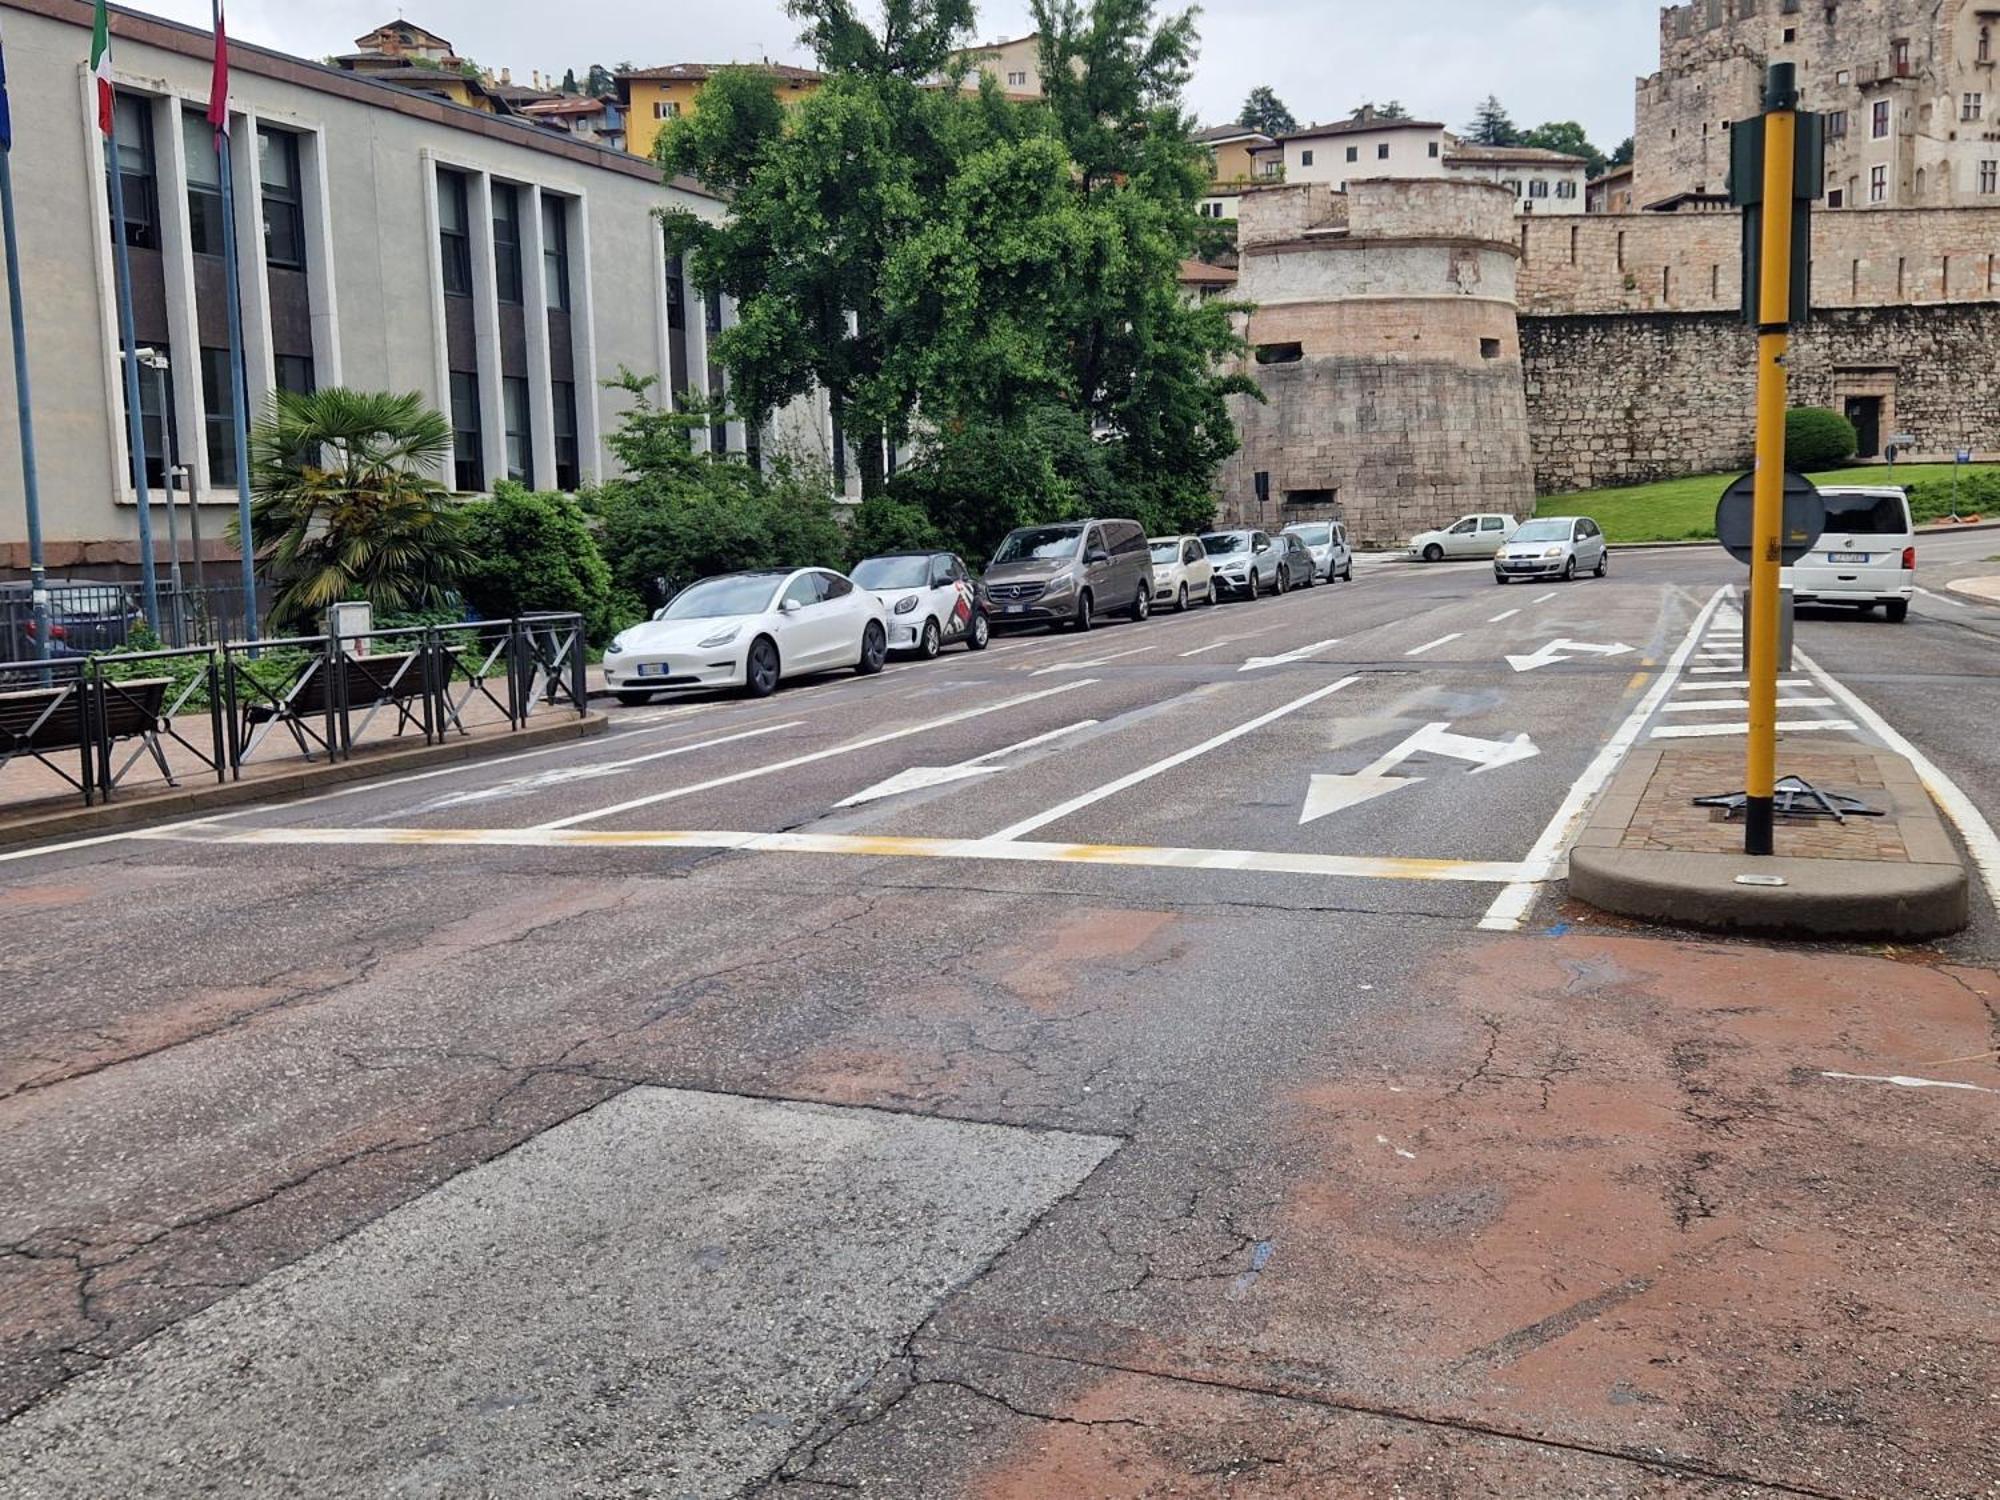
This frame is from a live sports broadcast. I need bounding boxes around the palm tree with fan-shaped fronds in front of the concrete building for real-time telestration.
[232,386,472,630]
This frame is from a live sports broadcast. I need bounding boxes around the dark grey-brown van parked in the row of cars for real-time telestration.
[986,520,1152,630]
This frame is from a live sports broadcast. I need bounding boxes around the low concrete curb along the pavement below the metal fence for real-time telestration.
[0,714,610,848]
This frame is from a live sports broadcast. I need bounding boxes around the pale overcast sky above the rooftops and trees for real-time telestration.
[126,0,1660,150]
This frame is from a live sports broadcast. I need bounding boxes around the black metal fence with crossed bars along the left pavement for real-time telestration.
[0,614,588,804]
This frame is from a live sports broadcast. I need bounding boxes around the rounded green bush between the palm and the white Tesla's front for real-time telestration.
[458,484,612,642]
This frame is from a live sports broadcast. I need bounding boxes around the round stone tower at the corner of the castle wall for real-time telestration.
[1220,178,1534,544]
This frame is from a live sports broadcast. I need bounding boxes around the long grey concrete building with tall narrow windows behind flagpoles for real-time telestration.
[0,0,828,572]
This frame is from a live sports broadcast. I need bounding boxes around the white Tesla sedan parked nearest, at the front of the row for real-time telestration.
[604,568,888,704]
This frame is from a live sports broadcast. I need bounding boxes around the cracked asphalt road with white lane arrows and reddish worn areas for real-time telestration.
[0,534,2000,1496]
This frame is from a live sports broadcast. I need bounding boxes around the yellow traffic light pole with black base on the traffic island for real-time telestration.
[1744,62,1798,854]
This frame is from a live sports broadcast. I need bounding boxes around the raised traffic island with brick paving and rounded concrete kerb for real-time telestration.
[1570,736,1970,938]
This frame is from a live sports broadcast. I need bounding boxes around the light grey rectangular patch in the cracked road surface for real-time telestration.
[0,1088,1118,1500]
